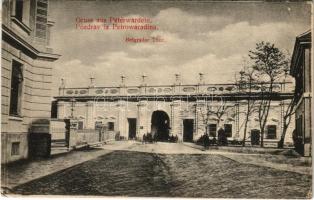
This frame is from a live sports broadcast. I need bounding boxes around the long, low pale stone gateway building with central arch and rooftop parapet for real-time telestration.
[55,81,294,147]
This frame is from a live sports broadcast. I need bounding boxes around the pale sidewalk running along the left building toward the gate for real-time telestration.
[1,141,133,189]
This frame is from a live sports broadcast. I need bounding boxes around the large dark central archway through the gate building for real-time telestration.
[151,110,170,141]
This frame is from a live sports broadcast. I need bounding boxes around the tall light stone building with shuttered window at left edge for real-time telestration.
[1,0,59,163]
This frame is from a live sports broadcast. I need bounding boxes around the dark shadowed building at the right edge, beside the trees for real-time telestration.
[290,31,313,156]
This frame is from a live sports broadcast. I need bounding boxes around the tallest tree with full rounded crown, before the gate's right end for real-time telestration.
[249,41,289,147]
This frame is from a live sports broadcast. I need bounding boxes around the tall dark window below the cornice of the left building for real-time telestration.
[10,60,23,116]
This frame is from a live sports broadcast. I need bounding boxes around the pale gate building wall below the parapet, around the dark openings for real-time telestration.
[58,100,294,147]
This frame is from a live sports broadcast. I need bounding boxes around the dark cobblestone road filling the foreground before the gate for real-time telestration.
[14,144,311,198]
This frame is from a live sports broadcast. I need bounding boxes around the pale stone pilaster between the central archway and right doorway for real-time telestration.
[170,100,183,142]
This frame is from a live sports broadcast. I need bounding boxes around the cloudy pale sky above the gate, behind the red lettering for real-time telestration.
[49,0,311,95]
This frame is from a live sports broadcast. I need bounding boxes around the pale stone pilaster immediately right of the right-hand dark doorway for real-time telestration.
[193,100,208,138]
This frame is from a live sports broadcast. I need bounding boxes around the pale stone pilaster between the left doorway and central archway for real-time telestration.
[136,100,149,139]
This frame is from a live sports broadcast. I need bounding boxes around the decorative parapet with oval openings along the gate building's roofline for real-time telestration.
[56,82,292,98]
